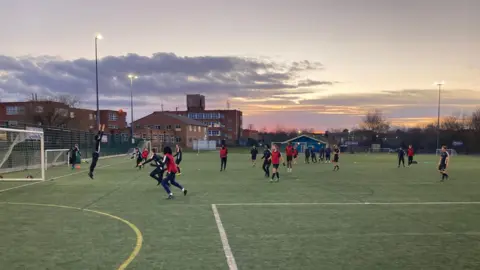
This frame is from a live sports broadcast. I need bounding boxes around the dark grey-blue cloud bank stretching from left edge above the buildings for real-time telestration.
[0,53,333,105]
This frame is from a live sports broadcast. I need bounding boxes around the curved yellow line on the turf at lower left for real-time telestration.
[0,202,143,270]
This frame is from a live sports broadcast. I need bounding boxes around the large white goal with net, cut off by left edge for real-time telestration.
[0,128,45,181]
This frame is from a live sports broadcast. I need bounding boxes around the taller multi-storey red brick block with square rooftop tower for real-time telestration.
[164,94,243,145]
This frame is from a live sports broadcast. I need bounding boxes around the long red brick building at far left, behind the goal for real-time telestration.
[0,101,128,134]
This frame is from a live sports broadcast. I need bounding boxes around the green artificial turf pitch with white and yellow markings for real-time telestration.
[0,152,480,270]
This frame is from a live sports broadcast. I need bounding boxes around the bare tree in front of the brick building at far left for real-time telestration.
[30,95,80,127]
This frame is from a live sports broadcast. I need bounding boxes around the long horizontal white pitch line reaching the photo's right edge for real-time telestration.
[216,202,480,206]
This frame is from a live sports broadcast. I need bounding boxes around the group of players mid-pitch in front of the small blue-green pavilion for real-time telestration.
[250,143,340,182]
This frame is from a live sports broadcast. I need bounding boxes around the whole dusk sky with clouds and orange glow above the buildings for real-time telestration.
[0,0,480,130]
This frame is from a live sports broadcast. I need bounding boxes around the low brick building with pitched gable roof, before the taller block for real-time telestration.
[133,112,208,148]
